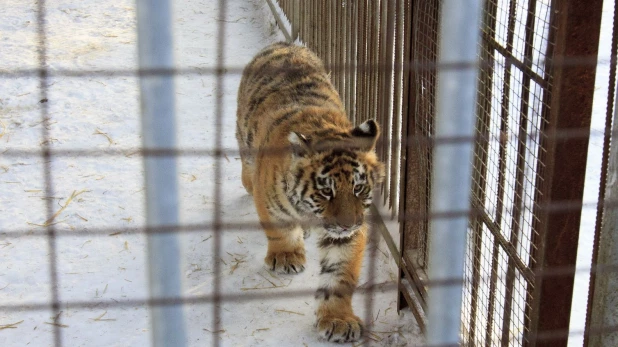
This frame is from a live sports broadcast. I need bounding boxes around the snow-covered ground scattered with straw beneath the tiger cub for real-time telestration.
[0,0,422,346]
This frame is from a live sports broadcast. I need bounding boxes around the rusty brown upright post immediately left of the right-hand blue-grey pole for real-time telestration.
[401,0,434,303]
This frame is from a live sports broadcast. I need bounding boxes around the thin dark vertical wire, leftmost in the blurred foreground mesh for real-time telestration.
[37,0,62,347]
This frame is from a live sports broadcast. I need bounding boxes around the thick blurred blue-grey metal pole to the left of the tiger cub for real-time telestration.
[137,0,186,346]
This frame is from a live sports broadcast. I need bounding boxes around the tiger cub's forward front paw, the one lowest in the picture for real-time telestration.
[316,314,363,343]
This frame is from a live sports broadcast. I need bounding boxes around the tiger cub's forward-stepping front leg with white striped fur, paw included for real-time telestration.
[315,226,367,342]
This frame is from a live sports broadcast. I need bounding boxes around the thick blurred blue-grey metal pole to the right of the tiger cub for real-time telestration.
[427,0,481,345]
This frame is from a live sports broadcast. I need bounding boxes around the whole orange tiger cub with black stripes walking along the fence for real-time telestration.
[236,43,384,342]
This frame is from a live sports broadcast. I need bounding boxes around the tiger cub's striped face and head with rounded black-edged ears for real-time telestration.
[287,120,384,238]
